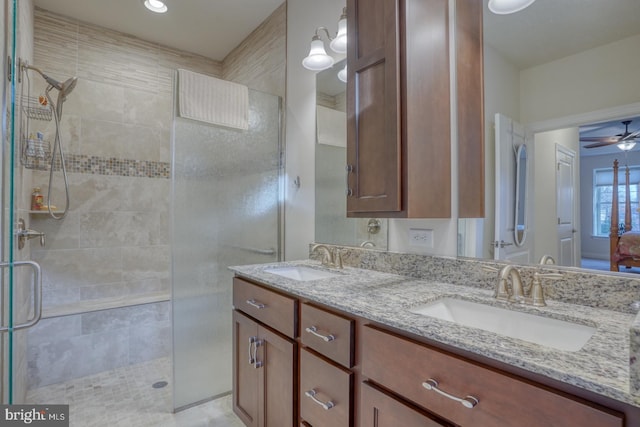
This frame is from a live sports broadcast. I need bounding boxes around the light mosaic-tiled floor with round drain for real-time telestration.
[27,358,243,427]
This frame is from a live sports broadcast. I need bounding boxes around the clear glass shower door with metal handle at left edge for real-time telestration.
[0,0,42,408]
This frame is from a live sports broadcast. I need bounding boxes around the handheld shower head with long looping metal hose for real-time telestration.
[20,61,78,219]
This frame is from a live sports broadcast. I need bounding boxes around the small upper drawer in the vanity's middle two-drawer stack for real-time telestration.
[300,303,355,368]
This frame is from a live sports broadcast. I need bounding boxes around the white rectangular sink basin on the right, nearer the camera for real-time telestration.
[409,298,596,351]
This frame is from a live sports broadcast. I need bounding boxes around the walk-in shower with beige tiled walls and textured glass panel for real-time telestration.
[0,0,282,414]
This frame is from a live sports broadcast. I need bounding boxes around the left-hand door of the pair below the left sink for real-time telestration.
[233,310,261,427]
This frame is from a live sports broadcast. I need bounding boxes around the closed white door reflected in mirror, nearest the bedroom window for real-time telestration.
[556,149,578,266]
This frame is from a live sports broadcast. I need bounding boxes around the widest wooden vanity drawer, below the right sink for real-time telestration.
[362,326,624,427]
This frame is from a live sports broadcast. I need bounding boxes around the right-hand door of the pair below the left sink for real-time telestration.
[257,326,297,427]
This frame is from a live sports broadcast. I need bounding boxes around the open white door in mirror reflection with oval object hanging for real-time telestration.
[493,113,533,263]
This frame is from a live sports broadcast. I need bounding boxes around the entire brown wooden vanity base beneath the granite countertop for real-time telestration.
[233,278,640,427]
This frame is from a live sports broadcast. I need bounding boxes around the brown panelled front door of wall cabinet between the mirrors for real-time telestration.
[347,0,402,216]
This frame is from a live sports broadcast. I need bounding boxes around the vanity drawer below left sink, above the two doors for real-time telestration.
[233,277,297,338]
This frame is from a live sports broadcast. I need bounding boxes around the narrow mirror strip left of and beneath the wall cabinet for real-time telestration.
[315,60,388,250]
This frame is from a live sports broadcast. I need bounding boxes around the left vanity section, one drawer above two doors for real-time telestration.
[232,278,298,427]
